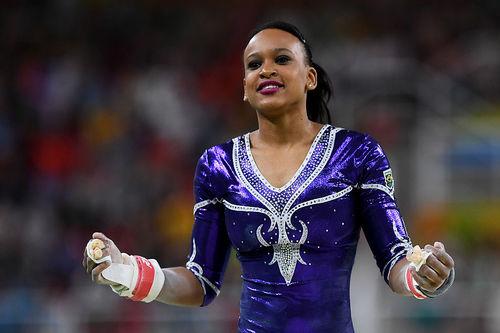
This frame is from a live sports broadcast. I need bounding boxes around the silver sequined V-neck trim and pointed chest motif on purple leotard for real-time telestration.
[230,125,352,285]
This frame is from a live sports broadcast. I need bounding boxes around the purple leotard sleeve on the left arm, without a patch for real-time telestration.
[186,151,231,306]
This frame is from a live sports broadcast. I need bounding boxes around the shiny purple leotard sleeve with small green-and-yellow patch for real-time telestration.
[358,138,411,282]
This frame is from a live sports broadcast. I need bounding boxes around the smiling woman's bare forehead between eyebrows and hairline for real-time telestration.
[243,29,303,58]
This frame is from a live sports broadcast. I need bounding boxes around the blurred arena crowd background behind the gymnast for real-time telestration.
[0,0,500,333]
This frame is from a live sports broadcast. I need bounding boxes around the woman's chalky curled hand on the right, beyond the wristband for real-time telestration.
[410,242,455,292]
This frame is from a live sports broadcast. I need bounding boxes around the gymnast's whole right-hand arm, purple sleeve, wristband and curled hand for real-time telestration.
[358,137,455,299]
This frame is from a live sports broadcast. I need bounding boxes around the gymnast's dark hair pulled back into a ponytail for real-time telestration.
[248,21,333,124]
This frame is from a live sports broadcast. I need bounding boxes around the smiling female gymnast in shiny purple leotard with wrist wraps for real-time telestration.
[83,22,454,333]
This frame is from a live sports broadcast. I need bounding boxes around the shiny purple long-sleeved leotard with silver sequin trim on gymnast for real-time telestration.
[186,125,411,333]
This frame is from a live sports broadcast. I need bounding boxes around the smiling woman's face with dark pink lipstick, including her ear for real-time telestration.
[243,29,317,113]
